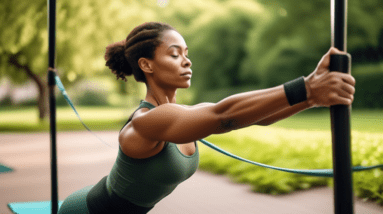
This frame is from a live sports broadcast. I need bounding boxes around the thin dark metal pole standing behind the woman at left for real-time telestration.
[48,0,58,214]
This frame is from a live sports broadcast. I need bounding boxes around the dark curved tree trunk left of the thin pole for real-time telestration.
[9,55,49,121]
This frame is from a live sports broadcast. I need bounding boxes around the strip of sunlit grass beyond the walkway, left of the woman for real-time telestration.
[0,106,133,132]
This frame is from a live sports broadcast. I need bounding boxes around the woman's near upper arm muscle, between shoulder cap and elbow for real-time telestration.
[132,104,221,143]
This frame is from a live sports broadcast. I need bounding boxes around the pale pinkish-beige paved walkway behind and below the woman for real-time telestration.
[0,131,383,214]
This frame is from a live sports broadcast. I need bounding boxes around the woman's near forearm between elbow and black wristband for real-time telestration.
[215,85,290,130]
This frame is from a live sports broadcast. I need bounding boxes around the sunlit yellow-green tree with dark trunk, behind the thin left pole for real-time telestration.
[0,0,154,120]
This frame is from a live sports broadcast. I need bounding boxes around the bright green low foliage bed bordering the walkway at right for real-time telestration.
[200,125,383,204]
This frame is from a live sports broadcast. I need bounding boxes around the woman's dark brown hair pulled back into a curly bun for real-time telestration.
[105,22,175,82]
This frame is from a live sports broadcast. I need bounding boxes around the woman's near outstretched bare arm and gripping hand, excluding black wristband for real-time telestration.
[132,48,355,143]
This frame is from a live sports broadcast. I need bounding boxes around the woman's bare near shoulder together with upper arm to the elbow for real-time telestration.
[119,103,221,151]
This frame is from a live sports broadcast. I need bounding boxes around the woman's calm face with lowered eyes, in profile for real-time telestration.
[151,30,192,88]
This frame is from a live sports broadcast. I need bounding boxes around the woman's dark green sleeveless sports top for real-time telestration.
[107,101,199,207]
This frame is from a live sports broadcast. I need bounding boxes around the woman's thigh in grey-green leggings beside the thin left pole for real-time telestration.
[58,186,93,214]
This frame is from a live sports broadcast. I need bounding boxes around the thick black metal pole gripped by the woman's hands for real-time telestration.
[330,0,354,214]
